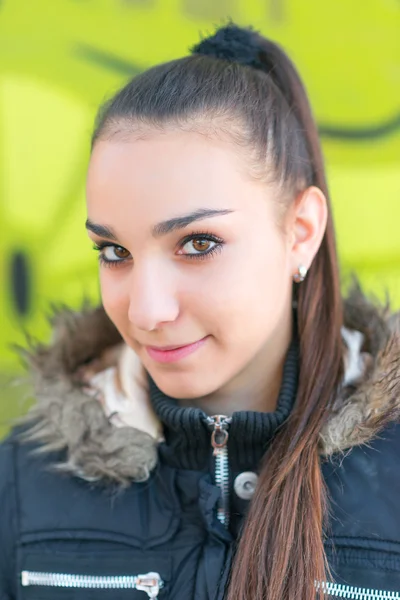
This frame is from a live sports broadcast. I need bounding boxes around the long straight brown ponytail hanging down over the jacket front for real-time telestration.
[227,31,343,600]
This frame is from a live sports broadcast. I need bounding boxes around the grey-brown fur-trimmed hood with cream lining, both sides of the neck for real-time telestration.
[16,287,400,485]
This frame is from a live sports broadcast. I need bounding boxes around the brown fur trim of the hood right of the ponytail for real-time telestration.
[320,286,400,455]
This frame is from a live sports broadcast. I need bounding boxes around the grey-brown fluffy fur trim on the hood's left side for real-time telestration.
[17,308,157,486]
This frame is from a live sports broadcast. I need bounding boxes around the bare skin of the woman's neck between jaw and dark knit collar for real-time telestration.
[181,319,293,416]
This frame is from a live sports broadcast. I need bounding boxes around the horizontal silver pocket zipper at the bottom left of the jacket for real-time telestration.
[21,571,164,599]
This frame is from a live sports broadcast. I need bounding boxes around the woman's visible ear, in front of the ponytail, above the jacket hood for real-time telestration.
[288,186,328,274]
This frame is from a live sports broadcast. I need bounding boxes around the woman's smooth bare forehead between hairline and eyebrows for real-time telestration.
[87,132,276,231]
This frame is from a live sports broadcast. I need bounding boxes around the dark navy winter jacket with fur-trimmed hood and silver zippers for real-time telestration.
[0,296,400,600]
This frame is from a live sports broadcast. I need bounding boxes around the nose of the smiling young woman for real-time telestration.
[128,264,179,331]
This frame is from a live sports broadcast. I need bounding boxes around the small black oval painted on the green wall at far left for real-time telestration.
[9,250,32,317]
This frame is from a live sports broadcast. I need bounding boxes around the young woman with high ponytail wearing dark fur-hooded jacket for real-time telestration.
[0,24,400,600]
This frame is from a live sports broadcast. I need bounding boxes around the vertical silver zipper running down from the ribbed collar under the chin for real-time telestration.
[207,415,232,527]
